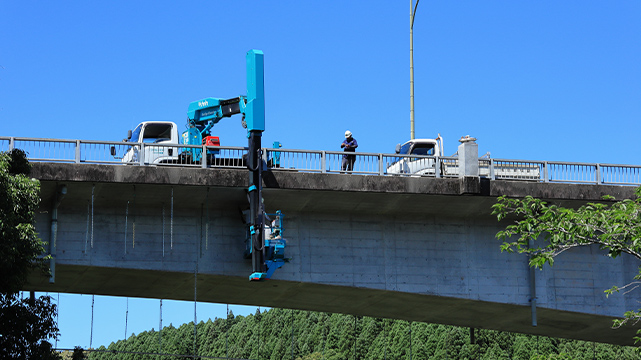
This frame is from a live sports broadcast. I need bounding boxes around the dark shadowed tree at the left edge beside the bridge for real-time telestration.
[0,149,59,359]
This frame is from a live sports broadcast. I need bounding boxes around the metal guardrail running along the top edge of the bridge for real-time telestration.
[0,137,641,185]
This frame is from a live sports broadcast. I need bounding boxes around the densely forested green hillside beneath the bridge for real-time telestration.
[89,309,641,360]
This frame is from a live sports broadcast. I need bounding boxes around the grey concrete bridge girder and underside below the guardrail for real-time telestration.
[26,163,638,345]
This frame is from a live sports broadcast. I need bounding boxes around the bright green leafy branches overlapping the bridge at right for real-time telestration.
[492,188,641,342]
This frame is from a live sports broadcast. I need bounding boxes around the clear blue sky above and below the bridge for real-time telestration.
[0,0,641,346]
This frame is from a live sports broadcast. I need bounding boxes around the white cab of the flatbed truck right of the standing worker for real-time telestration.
[387,135,443,175]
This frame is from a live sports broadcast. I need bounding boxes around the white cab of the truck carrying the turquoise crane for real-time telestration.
[122,121,179,164]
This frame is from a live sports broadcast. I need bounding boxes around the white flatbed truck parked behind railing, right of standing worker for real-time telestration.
[387,134,541,181]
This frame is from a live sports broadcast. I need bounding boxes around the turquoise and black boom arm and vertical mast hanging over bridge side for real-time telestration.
[182,50,284,280]
